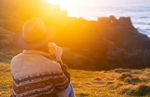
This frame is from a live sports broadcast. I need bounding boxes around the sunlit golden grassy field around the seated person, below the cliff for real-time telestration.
[0,63,150,97]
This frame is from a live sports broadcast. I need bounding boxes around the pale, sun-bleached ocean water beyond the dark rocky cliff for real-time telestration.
[44,0,150,37]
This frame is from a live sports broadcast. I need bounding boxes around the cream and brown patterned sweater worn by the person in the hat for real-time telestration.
[11,50,70,97]
